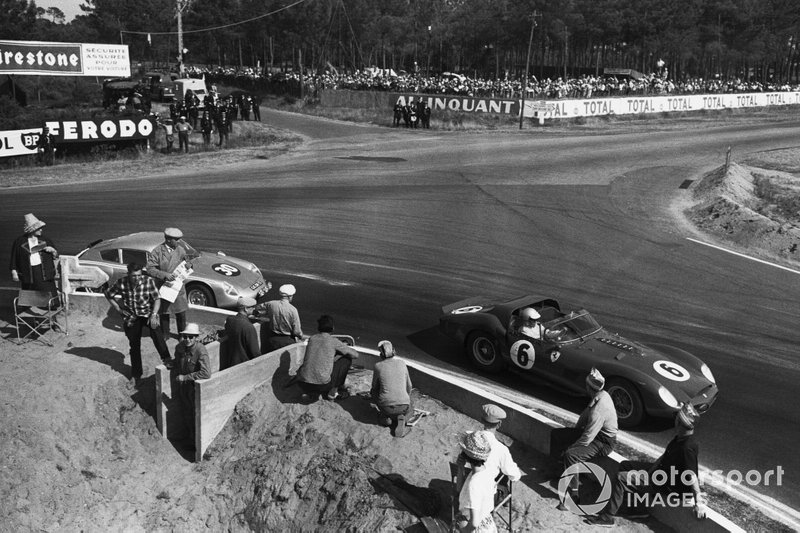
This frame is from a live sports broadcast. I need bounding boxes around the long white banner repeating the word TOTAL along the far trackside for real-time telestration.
[524,91,800,119]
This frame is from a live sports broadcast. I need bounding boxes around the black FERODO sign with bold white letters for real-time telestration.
[45,118,155,143]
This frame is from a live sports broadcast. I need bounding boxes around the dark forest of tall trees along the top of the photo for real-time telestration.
[0,0,800,81]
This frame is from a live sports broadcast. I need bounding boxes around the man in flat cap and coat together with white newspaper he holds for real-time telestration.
[145,228,195,339]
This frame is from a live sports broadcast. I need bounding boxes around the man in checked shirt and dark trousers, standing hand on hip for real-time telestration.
[105,263,172,384]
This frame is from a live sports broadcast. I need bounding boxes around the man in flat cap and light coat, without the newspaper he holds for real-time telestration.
[145,228,195,339]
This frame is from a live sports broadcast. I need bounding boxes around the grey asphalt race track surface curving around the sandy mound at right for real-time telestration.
[0,112,800,508]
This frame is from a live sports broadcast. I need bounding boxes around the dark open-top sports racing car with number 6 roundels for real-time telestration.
[439,296,718,427]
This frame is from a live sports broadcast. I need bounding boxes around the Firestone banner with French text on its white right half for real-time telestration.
[0,40,131,77]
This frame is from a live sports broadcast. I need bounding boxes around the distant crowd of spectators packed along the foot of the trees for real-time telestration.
[188,67,800,100]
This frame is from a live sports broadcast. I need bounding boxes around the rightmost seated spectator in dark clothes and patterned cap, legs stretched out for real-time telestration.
[586,403,707,527]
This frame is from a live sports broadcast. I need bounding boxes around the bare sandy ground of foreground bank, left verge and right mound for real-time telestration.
[0,114,800,532]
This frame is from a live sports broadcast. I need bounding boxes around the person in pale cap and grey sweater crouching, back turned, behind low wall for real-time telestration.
[370,341,414,437]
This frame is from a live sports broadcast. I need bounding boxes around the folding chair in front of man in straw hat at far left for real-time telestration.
[14,289,69,346]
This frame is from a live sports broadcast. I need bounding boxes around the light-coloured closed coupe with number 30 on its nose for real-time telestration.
[78,231,272,308]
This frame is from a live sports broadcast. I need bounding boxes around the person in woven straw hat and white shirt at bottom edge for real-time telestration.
[456,431,497,532]
